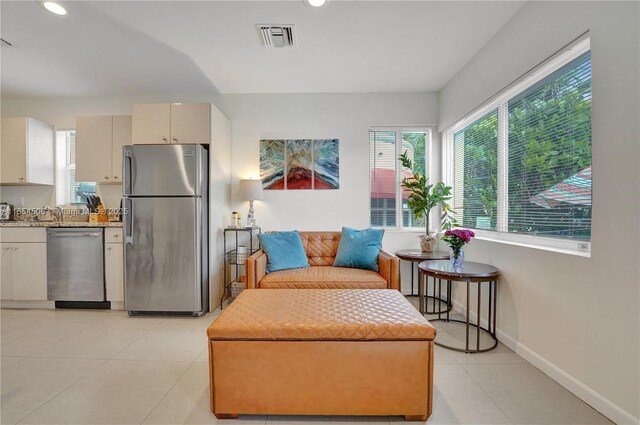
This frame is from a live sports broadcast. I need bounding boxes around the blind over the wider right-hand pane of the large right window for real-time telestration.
[508,52,591,241]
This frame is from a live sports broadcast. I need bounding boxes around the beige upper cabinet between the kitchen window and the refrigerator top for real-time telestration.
[76,115,131,183]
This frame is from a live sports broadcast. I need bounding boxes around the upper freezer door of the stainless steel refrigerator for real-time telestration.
[122,145,206,196]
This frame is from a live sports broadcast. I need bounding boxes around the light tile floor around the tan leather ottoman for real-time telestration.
[0,302,611,425]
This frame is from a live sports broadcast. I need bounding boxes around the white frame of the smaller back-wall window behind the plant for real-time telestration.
[369,125,437,233]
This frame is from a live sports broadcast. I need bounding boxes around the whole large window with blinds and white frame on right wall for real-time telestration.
[444,37,591,253]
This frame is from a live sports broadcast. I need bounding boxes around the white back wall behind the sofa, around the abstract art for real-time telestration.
[224,93,438,268]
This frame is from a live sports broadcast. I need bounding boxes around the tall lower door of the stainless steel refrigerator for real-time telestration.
[124,198,202,312]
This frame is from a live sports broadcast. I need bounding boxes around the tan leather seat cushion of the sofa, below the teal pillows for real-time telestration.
[260,266,387,289]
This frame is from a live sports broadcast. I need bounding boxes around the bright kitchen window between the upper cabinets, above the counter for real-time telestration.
[56,130,96,205]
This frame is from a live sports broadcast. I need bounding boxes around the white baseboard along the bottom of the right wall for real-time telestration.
[453,299,640,425]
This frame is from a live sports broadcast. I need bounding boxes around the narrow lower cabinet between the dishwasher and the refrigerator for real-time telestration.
[104,229,124,310]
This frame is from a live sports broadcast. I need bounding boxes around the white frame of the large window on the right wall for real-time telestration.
[442,33,591,257]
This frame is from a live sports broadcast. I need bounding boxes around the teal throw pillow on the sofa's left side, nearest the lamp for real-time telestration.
[258,230,309,273]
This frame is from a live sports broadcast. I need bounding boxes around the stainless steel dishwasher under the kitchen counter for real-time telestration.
[47,227,110,308]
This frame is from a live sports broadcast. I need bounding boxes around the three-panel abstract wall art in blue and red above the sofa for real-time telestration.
[260,139,340,190]
